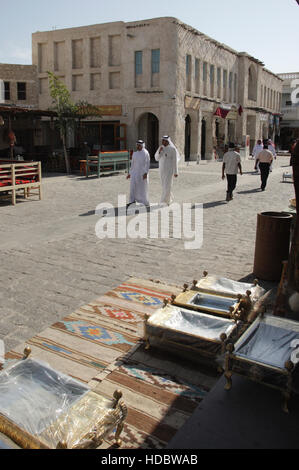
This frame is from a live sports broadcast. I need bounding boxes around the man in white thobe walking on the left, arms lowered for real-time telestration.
[127,140,151,207]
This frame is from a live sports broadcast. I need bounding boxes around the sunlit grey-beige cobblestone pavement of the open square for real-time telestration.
[0,157,294,350]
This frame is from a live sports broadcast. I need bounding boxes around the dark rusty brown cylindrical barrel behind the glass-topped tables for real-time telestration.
[253,212,293,281]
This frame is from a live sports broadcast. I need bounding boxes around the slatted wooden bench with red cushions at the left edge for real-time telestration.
[0,160,42,205]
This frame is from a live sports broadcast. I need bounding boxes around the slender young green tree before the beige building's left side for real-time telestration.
[48,72,100,174]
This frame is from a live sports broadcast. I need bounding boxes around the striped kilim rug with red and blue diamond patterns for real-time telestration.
[6,278,217,449]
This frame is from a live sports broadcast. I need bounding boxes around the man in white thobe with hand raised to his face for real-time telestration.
[155,136,180,205]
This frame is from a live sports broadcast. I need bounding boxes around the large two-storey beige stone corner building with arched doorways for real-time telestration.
[32,17,282,161]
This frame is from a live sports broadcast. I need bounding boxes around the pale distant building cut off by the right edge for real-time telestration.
[279,72,299,150]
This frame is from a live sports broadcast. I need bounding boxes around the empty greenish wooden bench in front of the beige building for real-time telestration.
[86,151,130,178]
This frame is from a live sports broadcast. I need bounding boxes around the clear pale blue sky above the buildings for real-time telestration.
[0,0,299,73]
